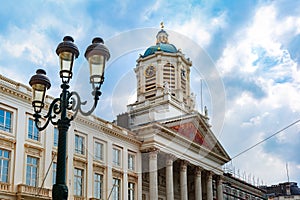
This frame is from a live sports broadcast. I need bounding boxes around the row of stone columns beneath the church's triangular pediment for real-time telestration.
[142,146,227,200]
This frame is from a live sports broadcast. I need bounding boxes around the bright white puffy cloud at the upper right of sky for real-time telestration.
[217,5,300,75]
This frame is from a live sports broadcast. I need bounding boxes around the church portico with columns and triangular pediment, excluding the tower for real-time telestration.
[134,111,229,200]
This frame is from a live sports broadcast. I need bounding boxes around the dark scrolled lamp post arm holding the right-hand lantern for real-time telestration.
[69,88,101,119]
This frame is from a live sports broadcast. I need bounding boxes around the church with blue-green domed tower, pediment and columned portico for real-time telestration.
[120,28,230,200]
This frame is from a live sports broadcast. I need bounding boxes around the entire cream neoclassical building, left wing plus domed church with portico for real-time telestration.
[0,27,266,200]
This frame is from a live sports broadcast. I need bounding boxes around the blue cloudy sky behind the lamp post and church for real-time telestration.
[0,0,300,185]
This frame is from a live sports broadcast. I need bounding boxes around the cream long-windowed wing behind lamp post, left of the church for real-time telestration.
[0,73,142,199]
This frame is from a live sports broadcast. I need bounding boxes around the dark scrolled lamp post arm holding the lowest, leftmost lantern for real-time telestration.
[33,98,61,131]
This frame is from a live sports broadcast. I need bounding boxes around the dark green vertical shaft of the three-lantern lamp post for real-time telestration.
[52,83,70,200]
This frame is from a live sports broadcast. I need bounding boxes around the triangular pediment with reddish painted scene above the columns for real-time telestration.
[162,113,230,162]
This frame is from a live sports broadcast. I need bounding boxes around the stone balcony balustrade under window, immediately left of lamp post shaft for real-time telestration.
[18,184,52,198]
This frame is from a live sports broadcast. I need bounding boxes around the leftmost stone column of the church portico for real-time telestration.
[149,150,158,199]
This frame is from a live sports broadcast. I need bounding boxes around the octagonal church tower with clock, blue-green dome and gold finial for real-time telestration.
[128,23,195,127]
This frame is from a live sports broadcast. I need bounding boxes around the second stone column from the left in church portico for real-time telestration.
[166,155,174,200]
